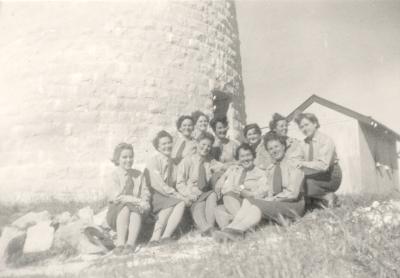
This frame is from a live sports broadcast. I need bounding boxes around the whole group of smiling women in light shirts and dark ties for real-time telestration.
[107,111,341,254]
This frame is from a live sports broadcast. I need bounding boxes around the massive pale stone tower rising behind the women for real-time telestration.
[0,0,246,202]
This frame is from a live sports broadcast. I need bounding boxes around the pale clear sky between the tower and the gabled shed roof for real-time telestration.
[236,0,400,133]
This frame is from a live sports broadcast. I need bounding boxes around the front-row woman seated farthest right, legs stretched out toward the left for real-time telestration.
[214,134,305,242]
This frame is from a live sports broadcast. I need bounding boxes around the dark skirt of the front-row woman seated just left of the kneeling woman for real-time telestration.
[247,198,305,223]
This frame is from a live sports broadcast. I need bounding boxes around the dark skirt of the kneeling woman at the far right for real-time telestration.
[305,164,342,197]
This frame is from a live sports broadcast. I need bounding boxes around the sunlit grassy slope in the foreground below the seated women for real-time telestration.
[0,196,400,278]
